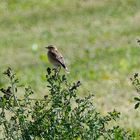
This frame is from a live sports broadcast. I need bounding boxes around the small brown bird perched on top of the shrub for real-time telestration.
[45,45,68,72]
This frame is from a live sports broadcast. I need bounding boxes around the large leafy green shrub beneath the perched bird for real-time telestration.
[0,68,133,140]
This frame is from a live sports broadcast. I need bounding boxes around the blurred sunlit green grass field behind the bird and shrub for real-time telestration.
[0,0,140,135]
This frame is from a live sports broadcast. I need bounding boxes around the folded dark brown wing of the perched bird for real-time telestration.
[52,50,66,68]
